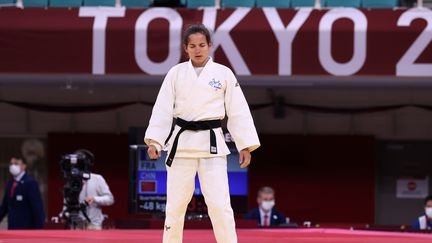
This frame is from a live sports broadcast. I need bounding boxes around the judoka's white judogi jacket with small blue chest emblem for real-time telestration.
[145,58,260,158]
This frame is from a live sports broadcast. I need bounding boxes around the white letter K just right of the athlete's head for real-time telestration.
[203,8,251,75]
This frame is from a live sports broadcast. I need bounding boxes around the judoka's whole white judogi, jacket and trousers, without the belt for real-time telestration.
[144,58,260,243]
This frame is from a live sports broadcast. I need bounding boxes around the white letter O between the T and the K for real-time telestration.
[135,8,183,74]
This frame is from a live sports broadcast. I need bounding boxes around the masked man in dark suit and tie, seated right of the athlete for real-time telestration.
[244,186,287,227]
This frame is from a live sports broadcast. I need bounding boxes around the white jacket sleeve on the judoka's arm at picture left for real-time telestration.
[144,68,175,148]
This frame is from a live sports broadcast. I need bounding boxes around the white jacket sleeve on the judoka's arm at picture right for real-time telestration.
[225,70,260,152]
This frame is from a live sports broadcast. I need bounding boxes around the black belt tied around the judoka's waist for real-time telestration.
[165,118,222,166]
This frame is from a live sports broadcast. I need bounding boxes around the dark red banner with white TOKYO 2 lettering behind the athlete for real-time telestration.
[0,7,432,76]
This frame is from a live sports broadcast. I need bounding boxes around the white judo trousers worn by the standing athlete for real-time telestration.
[163,156,237,243]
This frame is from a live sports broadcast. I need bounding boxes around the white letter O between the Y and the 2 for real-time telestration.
[318,8,367,75]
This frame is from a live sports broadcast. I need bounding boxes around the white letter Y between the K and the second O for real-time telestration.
[263,8,312,75]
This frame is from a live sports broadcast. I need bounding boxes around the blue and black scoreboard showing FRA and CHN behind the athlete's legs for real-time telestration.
[135,133,248,213]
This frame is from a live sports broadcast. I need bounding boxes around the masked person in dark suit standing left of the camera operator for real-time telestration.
[0,157,45,229]
